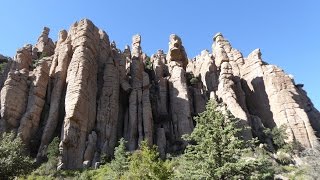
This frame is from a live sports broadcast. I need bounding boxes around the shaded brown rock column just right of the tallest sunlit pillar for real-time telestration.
[96,38,120,157]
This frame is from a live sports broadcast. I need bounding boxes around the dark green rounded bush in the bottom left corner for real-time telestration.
[0,133,33,179]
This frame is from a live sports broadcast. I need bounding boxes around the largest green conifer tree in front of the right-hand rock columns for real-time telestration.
[175,101,272,179]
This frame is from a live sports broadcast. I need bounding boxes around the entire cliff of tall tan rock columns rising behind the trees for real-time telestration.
[0,19,320,169]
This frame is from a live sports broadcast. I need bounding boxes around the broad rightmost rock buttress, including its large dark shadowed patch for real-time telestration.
[241,49,319,147]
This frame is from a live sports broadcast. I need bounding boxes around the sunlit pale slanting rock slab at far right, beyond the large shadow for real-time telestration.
[263,65,319,147]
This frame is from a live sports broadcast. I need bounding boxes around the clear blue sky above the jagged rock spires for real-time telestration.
[0,0,320,109]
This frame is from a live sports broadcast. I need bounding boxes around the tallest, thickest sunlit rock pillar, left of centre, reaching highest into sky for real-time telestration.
[61,19,100,169]
